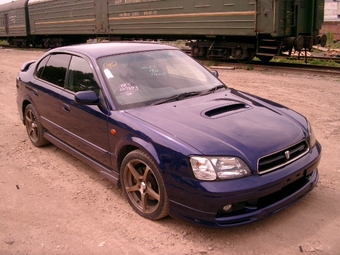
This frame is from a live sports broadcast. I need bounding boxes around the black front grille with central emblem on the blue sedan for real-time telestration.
[257,141,309,174]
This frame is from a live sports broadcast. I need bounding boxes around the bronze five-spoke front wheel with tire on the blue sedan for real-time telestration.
[120,150,169,220]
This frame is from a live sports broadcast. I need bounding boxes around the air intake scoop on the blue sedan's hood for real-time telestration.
[201,100,252,118]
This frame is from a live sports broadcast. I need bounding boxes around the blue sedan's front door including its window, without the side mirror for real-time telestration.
[60,56,112,168]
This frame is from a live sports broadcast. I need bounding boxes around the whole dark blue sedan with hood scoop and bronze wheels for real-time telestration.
[16,42,321,227]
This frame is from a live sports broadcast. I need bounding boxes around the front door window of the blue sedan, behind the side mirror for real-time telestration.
[66,56,99,96]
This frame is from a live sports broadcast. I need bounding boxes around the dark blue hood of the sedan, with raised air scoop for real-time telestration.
[127,91,305,161]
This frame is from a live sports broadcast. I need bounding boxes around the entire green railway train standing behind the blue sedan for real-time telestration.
[0,0,327,62]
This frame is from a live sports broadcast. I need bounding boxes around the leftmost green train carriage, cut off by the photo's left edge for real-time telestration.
[0,0,29,46]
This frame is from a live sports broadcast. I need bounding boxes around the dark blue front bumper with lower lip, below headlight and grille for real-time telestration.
[168,141,321,228]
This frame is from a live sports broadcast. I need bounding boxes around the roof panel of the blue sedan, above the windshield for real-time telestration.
[50,42,178,58]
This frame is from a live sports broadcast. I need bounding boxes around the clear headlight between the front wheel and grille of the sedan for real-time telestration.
[190,156,251,181]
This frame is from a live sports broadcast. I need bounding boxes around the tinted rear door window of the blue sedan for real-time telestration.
[36,54,71,87]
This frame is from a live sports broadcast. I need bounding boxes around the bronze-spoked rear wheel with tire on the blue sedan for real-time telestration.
[24,104,49,147]
